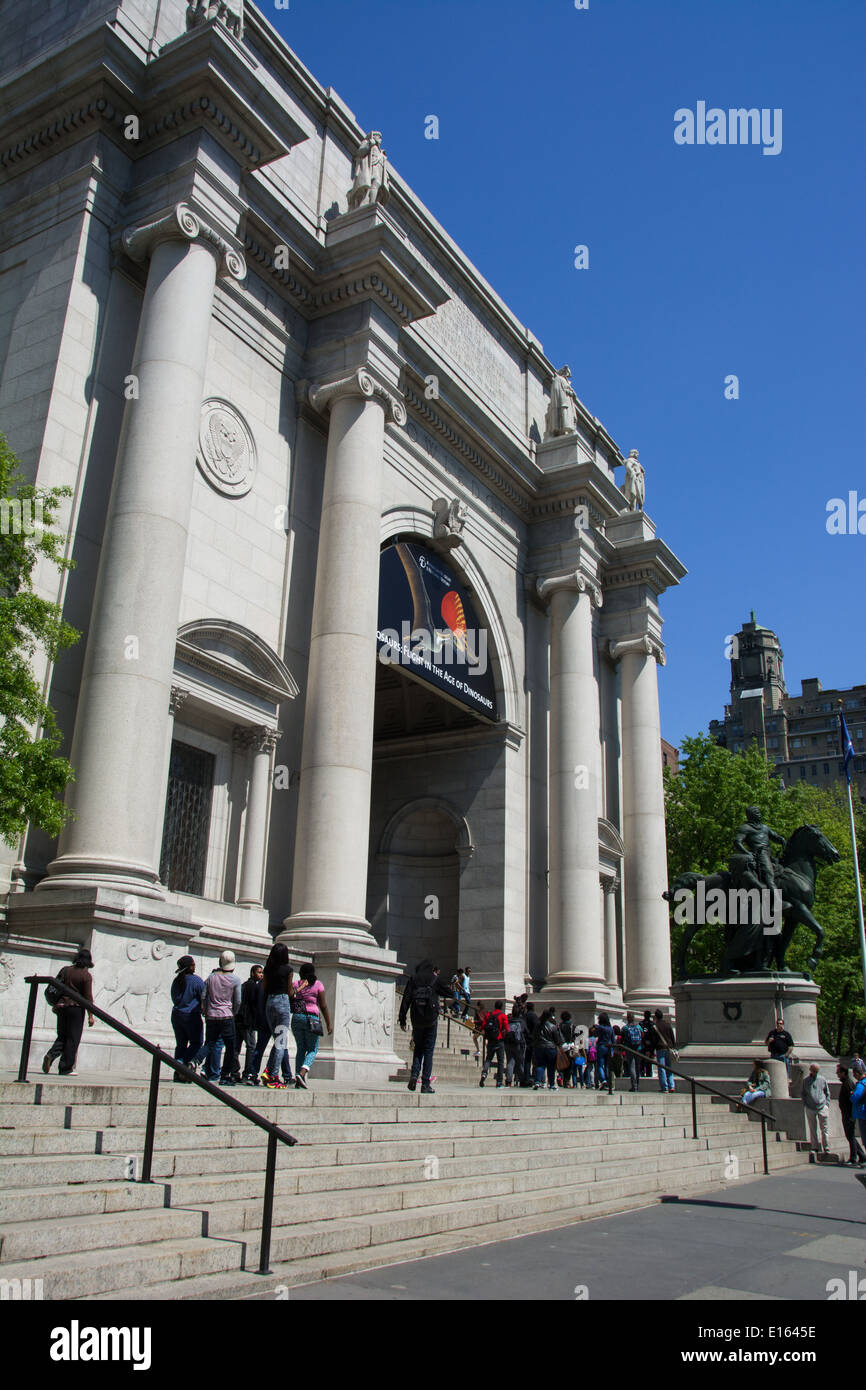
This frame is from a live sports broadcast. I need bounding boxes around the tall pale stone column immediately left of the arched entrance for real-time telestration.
[284,371,406,942]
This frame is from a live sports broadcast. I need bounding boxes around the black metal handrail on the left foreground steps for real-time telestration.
[17,974,297,1275]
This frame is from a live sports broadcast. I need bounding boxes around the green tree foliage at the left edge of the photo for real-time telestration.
[0,435,81,845]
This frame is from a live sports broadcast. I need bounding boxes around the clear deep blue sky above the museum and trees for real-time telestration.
[271,0,866,742]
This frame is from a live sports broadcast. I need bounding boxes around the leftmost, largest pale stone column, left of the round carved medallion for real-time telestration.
[43,204,245,897]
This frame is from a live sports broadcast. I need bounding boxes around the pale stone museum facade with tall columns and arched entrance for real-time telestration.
[0,0,685,1079]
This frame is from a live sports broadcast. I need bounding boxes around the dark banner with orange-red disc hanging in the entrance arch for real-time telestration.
[377,541,499,719]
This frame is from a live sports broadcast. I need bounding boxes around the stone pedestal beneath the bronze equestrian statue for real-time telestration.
[671,972,835,1083]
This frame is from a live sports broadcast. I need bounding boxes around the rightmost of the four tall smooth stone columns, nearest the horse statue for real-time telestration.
[612,637,670,1009]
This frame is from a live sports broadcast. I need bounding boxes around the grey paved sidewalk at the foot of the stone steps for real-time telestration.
[291,1166,866,1302]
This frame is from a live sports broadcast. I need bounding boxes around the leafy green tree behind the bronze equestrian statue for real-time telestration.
[664,734,866,1052]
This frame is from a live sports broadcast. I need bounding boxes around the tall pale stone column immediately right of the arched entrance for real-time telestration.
[538,574,605,988]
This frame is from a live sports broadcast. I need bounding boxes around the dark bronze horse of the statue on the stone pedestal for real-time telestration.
[662,826,840,980]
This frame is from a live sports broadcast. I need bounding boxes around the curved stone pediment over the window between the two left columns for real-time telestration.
[177,619,299,705]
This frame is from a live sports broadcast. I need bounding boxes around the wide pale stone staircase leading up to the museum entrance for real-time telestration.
[0,1077,808,1300]
